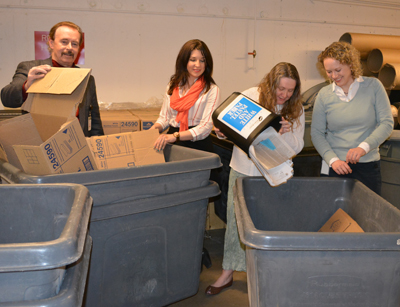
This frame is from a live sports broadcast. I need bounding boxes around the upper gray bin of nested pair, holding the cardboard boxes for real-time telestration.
[0,145,221,206]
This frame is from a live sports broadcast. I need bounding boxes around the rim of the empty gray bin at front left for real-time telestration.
[0,183,93,272]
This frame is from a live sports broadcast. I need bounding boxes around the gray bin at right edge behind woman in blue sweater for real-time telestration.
[379,130,400,208]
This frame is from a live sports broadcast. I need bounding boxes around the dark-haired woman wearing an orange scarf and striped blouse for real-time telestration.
[151,39,220,152]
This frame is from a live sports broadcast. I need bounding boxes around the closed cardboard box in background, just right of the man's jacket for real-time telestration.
[100,110,140,135]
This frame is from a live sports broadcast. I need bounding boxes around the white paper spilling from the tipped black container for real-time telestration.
[249,127,296,187]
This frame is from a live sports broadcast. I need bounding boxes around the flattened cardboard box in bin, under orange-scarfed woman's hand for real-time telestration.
[87,130,165,169]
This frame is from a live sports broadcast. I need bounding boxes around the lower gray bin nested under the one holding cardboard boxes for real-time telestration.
[86,183,219,307]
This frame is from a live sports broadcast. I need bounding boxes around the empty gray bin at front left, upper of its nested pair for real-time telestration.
[0,184,92,306]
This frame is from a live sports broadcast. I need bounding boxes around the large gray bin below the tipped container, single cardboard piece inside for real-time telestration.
[235,177,400,307]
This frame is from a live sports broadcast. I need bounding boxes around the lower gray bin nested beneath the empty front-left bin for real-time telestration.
[0,235,92,307]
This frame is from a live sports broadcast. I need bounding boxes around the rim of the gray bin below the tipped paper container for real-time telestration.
[234,177,400,251]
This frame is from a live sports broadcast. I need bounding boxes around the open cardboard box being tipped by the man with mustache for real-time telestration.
[0,67,97,175]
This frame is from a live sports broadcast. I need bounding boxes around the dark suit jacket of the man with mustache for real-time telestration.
[1,58,104,136]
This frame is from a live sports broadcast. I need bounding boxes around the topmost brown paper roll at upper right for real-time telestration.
[339,32,400,59]
